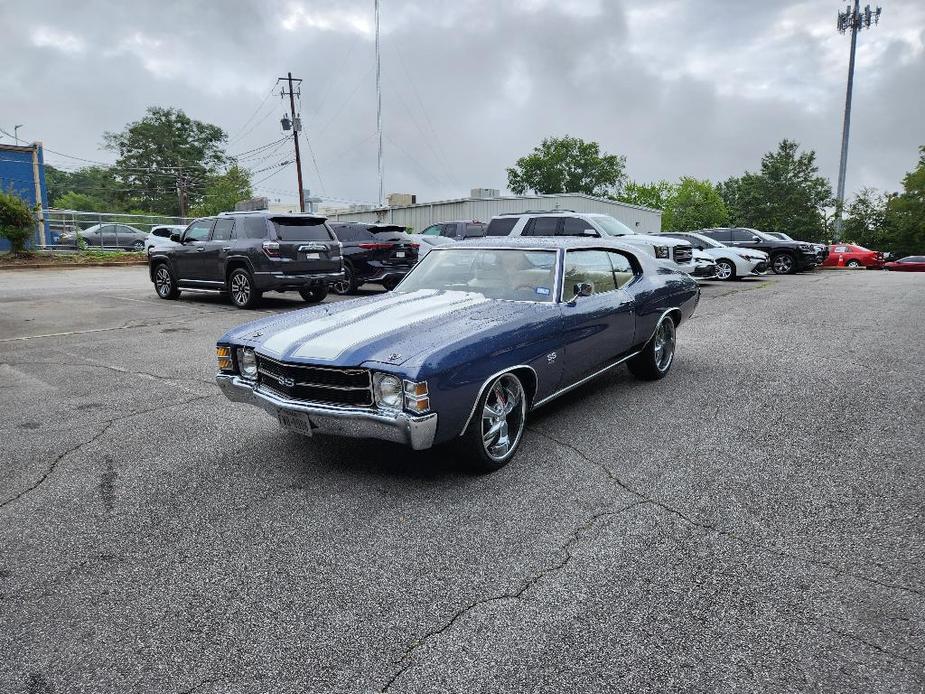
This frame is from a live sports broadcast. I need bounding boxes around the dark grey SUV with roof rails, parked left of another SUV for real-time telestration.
[148,212,344,308]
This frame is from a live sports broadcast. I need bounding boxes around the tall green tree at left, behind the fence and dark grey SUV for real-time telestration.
[103,106,227,215]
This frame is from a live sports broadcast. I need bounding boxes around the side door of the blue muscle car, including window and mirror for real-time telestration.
[562,249,636,385]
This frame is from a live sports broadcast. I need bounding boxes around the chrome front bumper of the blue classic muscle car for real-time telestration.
[215,374,437,451]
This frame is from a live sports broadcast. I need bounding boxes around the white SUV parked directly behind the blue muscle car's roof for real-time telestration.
[485,210,695,274]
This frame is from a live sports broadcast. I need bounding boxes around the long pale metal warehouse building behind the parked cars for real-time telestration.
[329,191,662,234]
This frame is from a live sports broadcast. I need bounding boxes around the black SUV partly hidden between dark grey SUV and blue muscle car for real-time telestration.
[329,222,418,294]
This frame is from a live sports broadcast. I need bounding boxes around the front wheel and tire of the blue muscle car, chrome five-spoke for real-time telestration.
[464,372,528,472]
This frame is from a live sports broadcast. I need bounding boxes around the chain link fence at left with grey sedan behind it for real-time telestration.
[42,209,192,252]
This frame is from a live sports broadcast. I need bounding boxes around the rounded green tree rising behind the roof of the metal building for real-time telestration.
[507,135,626,196]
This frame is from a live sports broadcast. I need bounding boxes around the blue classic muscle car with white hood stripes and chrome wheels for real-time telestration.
[216,237,700,470]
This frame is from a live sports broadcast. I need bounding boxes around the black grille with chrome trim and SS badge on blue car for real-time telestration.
[257,355,373,407]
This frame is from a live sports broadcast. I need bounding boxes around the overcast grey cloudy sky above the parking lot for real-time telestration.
[0,0,925,208]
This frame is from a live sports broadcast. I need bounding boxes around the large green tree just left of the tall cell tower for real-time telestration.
[718,140,832,241]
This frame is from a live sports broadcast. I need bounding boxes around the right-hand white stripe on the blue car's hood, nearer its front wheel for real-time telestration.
[292,292,488,359]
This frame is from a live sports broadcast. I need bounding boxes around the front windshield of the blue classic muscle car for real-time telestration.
[395,248,556,303]
